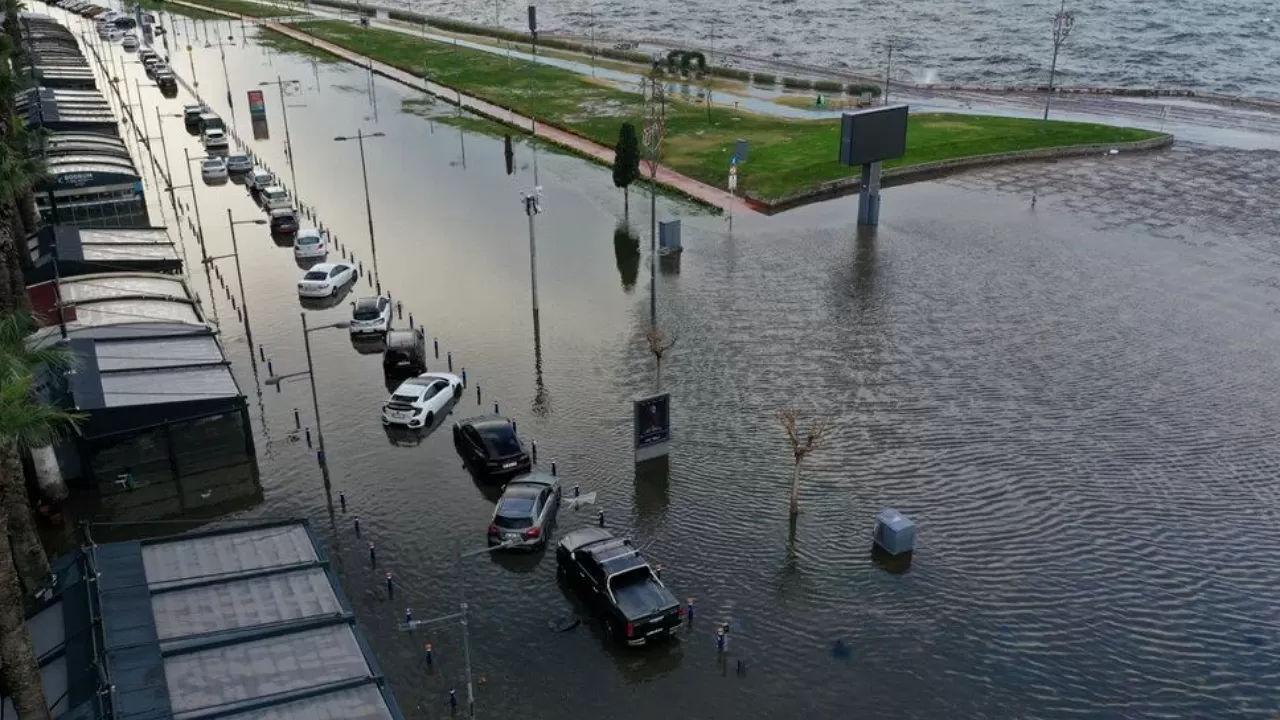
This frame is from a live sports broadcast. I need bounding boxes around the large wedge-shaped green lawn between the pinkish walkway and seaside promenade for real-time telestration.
[272,20,1172,199]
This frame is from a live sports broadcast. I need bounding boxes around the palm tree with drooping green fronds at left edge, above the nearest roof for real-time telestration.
[0,313,79,596]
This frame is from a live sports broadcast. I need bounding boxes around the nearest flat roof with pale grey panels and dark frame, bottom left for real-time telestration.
[3,520,403,720]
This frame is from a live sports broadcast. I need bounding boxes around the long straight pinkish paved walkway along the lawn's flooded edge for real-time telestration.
[172,0,760,213]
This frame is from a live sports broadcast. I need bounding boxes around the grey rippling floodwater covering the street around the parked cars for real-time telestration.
[67,11,1280,719]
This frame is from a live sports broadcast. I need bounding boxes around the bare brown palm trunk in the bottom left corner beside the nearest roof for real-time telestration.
[0,476,49,720]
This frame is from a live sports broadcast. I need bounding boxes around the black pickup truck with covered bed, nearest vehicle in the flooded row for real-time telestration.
[556,520,684,646]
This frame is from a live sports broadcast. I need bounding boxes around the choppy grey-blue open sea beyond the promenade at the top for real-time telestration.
[401,0,1280,99]
